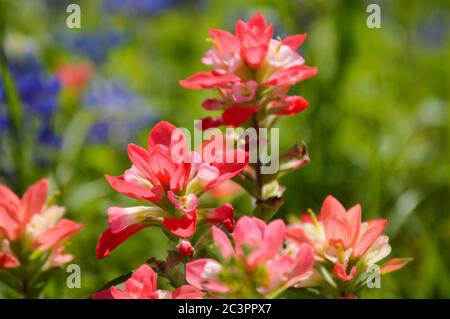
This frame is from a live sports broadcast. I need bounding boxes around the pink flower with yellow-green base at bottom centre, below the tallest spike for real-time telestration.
[186,216,314,298]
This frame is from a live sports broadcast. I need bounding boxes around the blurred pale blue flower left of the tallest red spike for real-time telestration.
[82,79,157,147]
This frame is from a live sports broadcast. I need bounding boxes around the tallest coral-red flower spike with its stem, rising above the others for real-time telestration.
[180,14,317,220]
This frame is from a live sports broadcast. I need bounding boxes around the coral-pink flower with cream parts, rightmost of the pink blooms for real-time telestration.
[286,196,410,293]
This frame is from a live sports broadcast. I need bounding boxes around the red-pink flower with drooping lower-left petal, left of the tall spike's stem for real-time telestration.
[97,122,248,258]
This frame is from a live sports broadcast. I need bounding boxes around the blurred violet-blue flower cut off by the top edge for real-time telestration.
[103,0,176,16]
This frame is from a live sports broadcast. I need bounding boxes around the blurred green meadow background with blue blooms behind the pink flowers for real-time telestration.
[0,0,450,298]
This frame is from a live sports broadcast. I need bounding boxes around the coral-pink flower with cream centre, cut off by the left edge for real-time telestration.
[0,179,82,268]
